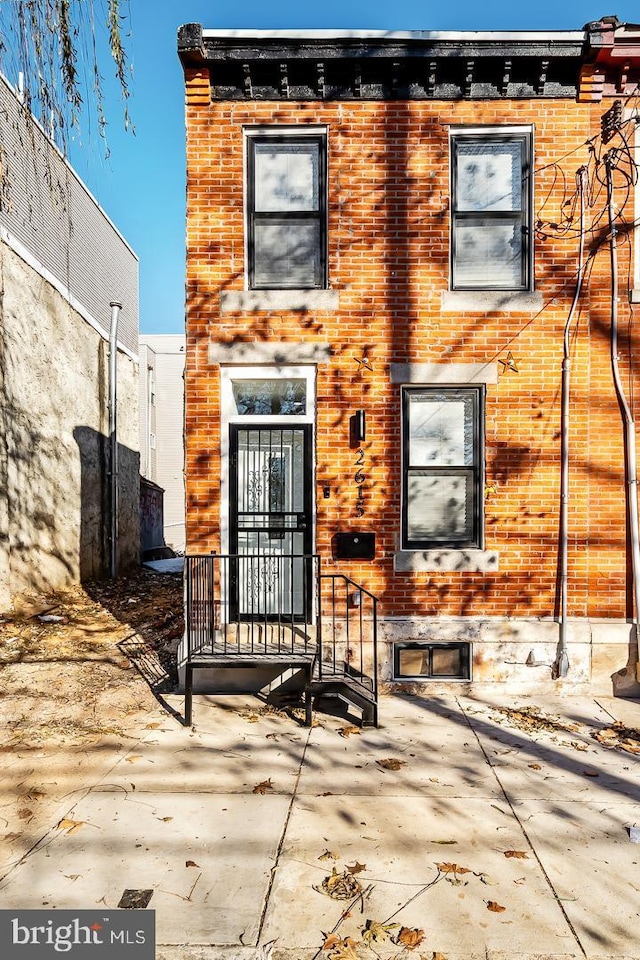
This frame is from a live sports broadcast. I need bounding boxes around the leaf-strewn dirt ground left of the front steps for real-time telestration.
[0,569,183,750]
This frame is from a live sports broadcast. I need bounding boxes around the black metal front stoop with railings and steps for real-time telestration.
[184,553,378,726]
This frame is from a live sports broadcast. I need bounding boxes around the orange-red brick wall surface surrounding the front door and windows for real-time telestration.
[186,67,632,617]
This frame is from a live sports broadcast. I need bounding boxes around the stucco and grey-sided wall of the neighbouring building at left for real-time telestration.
[0,73,140,608]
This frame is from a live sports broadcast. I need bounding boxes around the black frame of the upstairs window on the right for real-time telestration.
[449,127,534,293]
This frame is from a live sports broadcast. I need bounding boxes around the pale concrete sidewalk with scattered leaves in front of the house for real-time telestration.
[0,695,640,960]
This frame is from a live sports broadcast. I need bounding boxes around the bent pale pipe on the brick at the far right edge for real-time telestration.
[604,151,640,680]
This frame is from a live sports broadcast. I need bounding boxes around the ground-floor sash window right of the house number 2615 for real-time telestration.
[402,386,484,550]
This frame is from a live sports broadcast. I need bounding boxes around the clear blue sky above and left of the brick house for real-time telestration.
[63,0,640,333]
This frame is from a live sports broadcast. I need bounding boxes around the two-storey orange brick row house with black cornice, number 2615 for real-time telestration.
[178,18,640,720]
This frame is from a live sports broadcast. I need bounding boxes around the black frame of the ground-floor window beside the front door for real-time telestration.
[401,384,486,550]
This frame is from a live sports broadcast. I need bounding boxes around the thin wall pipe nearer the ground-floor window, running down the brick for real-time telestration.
[556,167,587,677]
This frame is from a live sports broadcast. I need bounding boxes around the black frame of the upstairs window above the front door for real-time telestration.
[247,132,328,290]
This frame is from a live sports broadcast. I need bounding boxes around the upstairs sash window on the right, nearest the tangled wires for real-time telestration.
[451,127,533,290]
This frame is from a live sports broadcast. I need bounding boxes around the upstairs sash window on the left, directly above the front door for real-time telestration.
[247,132,327,290]
